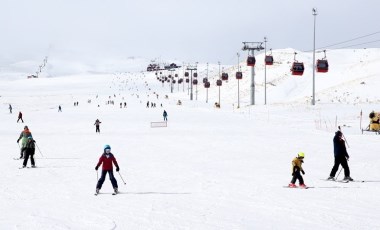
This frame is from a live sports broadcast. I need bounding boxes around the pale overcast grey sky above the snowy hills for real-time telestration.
[0,0,380,64]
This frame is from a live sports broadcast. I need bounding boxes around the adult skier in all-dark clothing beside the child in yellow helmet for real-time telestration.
[327,130,353,181]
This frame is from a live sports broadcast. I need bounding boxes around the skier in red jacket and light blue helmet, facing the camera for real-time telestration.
[95,145,120,194]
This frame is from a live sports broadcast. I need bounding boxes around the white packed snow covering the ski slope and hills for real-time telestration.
[0,49,380,230]
